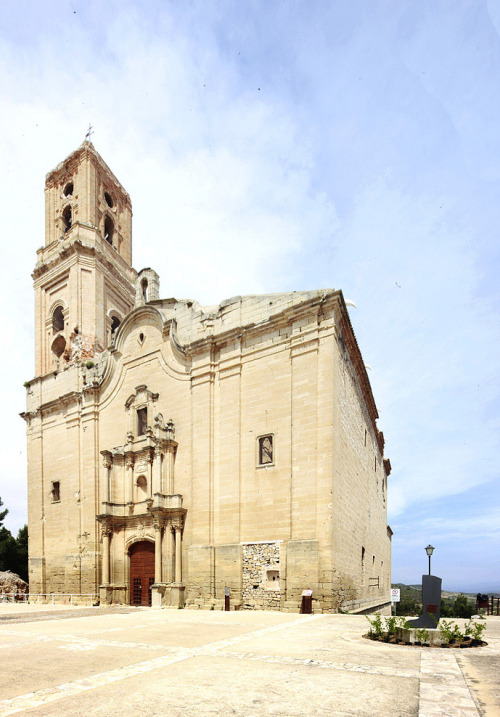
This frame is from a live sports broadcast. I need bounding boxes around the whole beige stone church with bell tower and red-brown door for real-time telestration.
[22,140,392,612]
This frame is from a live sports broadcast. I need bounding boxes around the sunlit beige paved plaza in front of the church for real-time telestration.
[0,605,500,717]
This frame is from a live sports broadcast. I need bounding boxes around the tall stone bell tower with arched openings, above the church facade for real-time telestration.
[33,140,137,376]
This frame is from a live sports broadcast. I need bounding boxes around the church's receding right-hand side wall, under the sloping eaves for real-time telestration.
[333,330,391,610]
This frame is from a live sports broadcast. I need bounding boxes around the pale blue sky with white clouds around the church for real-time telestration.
[0,0,500,591]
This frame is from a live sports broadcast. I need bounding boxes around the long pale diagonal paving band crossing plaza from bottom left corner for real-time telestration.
[0,615,322,717]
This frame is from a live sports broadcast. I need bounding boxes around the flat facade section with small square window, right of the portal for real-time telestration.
[193,308,333,609]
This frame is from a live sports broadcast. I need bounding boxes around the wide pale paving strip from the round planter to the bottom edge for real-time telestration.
[418,650,480,717]
